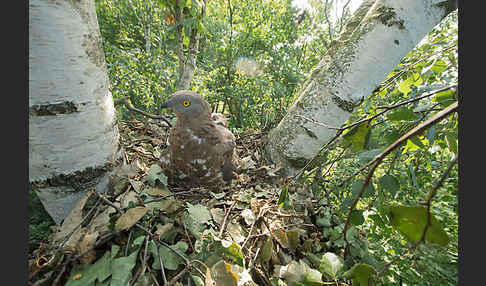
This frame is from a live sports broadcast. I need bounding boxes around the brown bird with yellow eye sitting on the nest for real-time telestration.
[160,90,237,187]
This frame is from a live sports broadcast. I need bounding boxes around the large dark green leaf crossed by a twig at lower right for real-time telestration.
[387,206,450,246]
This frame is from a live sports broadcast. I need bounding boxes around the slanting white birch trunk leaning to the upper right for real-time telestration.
[266,0,457,175]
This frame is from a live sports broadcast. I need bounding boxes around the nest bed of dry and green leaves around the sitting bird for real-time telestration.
[29,119,370,286]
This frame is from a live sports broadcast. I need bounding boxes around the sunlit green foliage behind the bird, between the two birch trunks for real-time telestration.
[96,0,340,129]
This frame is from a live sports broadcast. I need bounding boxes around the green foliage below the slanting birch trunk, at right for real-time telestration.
[302,12,458,285]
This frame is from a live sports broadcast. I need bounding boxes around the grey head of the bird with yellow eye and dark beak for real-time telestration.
[160,90,211,120]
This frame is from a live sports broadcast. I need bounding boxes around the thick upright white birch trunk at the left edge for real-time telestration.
[29,0,121,224]
